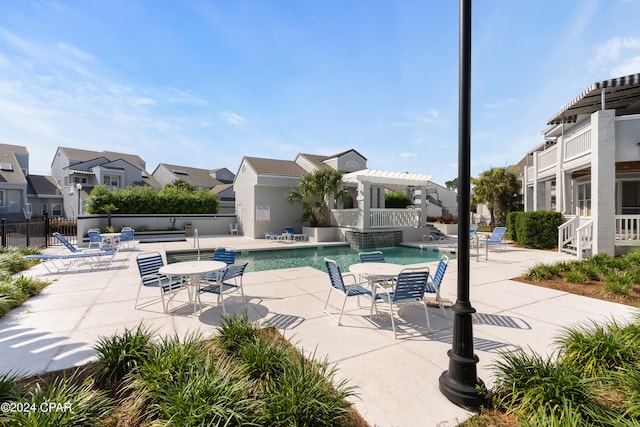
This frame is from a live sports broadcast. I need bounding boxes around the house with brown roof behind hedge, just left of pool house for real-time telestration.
[152,163,235,214]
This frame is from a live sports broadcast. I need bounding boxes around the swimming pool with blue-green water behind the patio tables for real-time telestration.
[167,246,455,271]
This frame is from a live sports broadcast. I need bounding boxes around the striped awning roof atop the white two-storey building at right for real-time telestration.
[547,73,640,125]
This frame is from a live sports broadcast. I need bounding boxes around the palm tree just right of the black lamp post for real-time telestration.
[471,168,520,228]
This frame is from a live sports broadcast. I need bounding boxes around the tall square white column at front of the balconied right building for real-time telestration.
[591,110,616,255]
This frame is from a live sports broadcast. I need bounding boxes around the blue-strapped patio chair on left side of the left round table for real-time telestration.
[134,252,185,313]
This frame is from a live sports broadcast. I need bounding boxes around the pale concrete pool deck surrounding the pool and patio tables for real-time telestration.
[0,236,635,427]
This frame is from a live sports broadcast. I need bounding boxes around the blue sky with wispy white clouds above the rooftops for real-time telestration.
[0,0,640,184]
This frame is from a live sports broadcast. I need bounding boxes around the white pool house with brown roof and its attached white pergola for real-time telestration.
[234,149,444,247]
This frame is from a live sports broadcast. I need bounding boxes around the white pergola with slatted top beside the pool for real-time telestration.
[342,169,431,229]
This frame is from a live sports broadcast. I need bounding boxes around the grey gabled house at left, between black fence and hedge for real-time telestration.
[51,147,161,218]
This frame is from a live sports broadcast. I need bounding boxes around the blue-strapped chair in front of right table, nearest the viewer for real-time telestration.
[370,267,431,338]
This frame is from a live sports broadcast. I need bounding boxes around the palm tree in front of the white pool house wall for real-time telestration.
[287,167,350,227]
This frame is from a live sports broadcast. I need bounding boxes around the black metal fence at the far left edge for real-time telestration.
[0,216,78,248]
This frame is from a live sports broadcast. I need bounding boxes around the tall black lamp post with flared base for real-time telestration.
[440,0,484,409]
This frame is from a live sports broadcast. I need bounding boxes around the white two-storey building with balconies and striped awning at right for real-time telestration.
[523,74,640,257]
